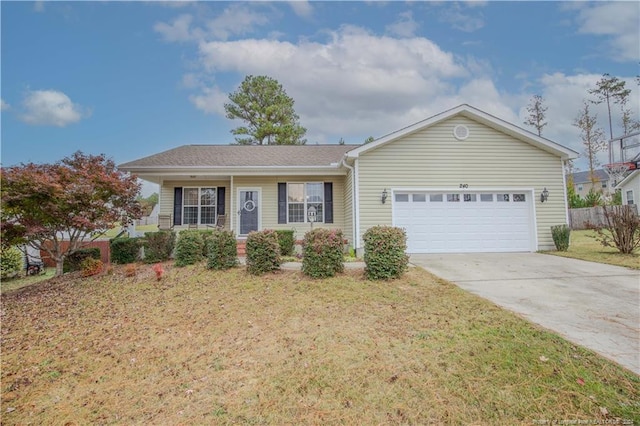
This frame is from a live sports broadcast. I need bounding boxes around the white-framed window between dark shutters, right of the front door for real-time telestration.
[287,182,324,223]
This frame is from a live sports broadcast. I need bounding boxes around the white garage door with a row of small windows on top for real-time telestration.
[393,191,533,253]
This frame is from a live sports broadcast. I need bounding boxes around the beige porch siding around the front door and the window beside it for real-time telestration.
[233,176,351,240]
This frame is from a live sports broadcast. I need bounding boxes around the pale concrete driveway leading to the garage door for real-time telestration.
[410,253,640,375]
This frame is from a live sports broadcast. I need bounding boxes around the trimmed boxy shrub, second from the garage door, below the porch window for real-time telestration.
[302,228,344,278]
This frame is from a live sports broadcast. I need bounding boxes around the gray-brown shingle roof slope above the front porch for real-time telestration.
[118,145,359,169]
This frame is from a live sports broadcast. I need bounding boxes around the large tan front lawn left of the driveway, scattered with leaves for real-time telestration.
[1,264,640,425]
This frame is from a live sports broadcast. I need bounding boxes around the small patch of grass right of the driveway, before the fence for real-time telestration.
[545,231,640,269]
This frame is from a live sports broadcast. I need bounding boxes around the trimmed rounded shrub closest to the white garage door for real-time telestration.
[362,226,409,280]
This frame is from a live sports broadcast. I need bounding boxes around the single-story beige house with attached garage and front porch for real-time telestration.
[119,105,577,253]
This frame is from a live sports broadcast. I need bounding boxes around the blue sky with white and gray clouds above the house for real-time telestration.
[0,1,640,193]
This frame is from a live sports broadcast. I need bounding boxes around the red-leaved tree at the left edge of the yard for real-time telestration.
[0,151,141,276]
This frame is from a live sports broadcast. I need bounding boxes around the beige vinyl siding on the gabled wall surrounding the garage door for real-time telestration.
[358,116,566,250]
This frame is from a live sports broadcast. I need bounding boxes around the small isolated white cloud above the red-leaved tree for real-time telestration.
[20,90,89,127]
